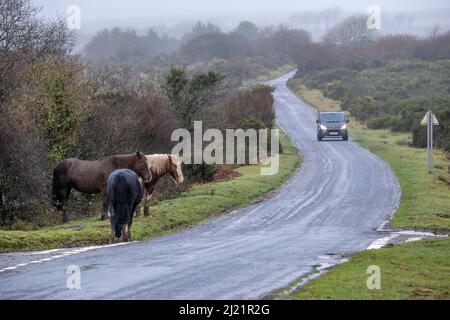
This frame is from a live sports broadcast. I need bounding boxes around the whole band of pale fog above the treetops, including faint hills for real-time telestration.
[32,0,450,38]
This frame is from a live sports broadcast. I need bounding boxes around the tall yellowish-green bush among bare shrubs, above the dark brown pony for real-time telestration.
[23,56,86,162]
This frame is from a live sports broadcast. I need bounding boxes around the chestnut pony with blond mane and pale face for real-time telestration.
[138,154,184,217]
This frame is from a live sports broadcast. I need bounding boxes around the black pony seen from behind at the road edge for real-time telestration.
[106,169,143,243]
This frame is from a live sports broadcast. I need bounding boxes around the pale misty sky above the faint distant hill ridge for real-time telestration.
[32,0,450,20]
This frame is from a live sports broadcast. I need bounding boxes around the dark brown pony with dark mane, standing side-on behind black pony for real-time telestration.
[53,151,152,222]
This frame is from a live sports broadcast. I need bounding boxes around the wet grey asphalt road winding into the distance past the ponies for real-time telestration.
[0,74,400,299]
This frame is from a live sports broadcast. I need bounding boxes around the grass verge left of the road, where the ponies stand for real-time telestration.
[0,133,300,252]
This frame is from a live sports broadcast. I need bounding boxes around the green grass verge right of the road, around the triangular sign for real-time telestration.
[284,80,450,300]
